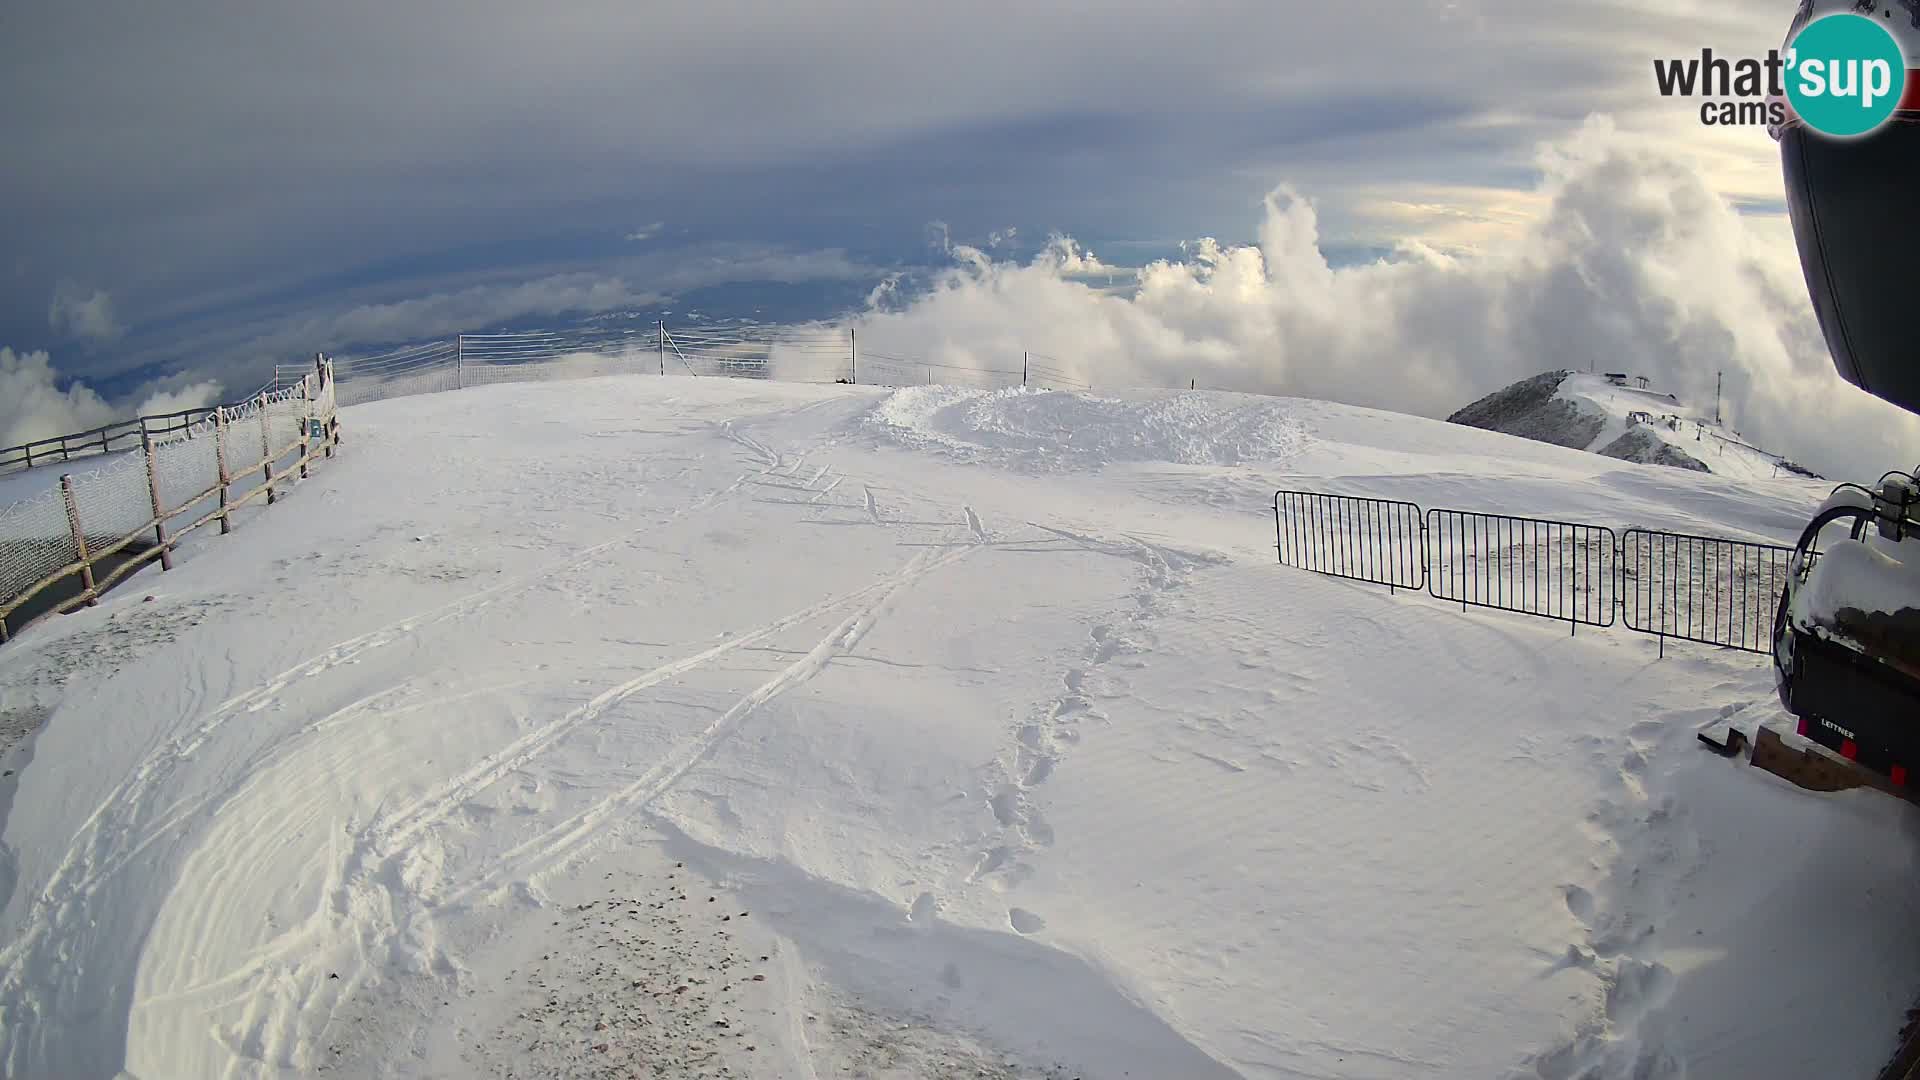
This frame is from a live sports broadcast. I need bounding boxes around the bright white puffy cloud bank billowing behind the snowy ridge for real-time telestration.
[806,117,1920,479]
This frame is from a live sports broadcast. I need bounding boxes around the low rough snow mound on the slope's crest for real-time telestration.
[862,386,1308,469]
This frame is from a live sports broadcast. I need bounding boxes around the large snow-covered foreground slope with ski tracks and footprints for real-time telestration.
[0,377,1920,1080]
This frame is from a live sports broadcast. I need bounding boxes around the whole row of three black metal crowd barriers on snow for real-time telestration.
[1273,490,1793,655]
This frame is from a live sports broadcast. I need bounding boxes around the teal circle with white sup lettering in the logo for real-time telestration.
[1788,13,1907,138]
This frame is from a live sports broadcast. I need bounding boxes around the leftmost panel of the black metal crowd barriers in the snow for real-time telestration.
[1273,492,1427,588]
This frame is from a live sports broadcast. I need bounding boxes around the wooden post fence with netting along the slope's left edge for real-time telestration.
[0,359,340,642]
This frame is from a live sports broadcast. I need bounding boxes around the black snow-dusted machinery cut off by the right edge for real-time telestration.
[1772,0,1920,772]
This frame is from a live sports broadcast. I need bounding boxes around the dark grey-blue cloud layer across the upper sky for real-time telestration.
[0,0,1791,390]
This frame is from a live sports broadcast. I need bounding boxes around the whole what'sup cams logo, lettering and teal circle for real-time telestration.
[1653,0,1920,138]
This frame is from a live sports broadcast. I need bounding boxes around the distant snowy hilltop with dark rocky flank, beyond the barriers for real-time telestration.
[1448,371,1809,480]
